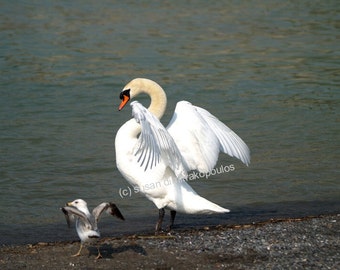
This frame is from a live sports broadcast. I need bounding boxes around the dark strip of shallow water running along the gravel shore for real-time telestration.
[0,200,340,247]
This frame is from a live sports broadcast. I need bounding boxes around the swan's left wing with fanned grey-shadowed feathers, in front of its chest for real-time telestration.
[131,101,187,179]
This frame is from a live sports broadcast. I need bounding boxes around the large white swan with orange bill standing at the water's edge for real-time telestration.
[115,78,250,232]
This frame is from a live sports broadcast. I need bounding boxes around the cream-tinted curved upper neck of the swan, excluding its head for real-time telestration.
[139,79,167,119]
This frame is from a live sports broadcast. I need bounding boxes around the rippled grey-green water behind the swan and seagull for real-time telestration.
[0,1,340,244]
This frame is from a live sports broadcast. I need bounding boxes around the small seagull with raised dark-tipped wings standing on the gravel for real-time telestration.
[61,199,125,259]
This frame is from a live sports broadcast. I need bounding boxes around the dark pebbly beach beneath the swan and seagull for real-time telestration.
[0,214,340,269]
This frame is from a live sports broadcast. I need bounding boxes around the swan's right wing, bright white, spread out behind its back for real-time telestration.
[167,101,250,172]
